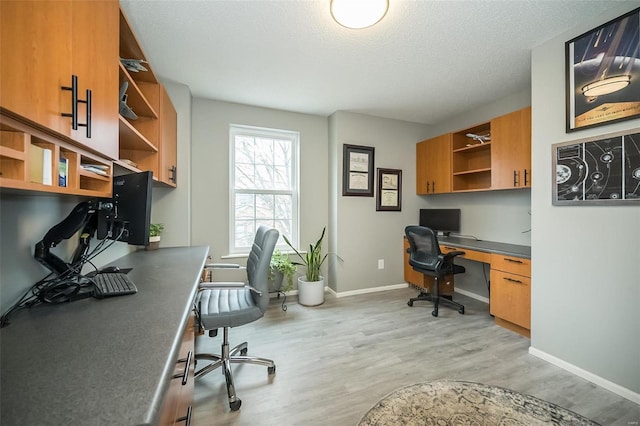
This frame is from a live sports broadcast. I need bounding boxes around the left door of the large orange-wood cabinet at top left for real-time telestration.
[0,0,72,133]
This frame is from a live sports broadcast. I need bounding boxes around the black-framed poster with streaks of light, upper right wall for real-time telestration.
[565,8,640,132]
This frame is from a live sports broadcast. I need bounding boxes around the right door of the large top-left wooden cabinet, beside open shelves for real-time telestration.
[70,0,120,159]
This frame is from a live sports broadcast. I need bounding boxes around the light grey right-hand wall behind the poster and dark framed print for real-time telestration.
[531,2,640,403]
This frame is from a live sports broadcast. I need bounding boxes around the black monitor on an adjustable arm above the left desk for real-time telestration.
[97,172,153,246]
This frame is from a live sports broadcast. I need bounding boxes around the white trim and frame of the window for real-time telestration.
[230,124,300,258]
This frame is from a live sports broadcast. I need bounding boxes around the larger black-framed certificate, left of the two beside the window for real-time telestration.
[342,144,375,197]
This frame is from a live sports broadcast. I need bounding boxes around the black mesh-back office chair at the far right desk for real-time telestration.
[404,225,465,317]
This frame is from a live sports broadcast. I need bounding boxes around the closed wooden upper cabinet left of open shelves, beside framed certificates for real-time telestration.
[416,133,451,195]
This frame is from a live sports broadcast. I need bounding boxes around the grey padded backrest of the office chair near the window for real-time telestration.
[247,226,280,312]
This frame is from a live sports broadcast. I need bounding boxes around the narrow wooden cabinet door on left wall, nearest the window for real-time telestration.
[159,86,178,186]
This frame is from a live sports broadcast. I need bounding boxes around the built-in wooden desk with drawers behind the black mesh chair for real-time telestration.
[404,237,531,337]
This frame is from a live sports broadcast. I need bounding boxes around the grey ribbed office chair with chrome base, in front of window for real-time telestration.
[195,226,279,411]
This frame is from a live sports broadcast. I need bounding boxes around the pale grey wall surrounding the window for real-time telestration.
[191,98,329,274]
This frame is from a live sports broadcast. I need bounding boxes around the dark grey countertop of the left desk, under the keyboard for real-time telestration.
[0,247,209,426]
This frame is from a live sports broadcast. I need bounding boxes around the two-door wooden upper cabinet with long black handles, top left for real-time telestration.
[0,0,118,158]
